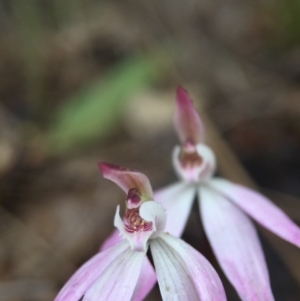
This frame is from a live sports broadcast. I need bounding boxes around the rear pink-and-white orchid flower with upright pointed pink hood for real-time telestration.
[155,87,300,301]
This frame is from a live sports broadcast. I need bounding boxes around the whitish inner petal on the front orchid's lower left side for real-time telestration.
[83,249,146,301]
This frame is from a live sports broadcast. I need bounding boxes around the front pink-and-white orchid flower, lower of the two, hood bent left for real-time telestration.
[55,163,226,301]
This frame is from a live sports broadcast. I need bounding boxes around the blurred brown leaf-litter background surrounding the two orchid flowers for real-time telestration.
[0,0,300,301]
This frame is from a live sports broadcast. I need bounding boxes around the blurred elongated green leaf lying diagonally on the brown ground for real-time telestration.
[45,55,163,154]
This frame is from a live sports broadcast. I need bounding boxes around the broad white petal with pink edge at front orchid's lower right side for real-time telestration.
[150,234,226,301]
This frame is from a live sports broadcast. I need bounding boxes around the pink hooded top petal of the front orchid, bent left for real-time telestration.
[99,162,153,199]
